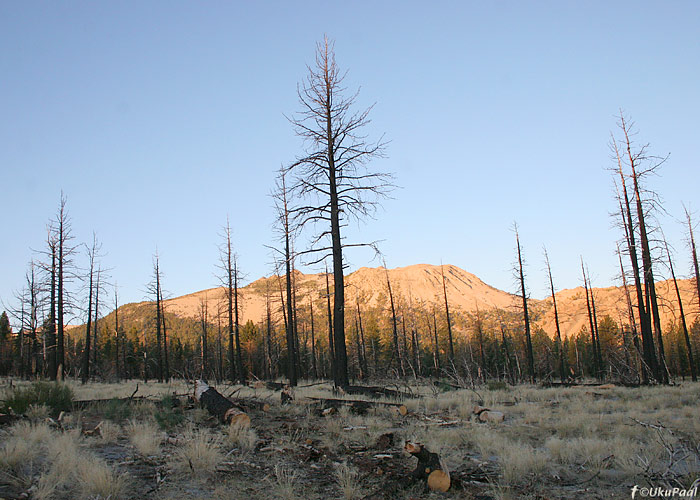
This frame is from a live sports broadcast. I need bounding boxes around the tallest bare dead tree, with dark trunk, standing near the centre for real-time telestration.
[287,38,390,387]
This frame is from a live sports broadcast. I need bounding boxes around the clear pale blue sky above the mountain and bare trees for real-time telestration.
[0,1,700,316]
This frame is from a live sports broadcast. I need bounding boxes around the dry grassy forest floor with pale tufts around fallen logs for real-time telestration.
[0,381,700,500]
